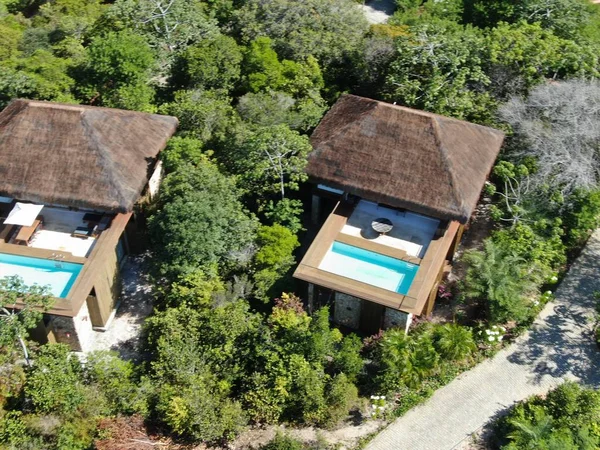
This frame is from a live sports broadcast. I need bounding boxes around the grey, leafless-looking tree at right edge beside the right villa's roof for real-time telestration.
[500,79,600,196]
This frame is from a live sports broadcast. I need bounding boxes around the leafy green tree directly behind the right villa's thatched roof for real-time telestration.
[382,20,493,122]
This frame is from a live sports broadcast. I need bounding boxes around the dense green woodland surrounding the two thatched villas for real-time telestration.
[0,0,600,450]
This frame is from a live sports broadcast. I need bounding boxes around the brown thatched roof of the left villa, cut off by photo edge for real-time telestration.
[0,100,177,212]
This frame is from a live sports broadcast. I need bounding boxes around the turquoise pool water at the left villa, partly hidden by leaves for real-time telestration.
[0,253,83,298]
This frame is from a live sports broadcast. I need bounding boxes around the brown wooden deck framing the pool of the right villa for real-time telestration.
[294,203,459,315]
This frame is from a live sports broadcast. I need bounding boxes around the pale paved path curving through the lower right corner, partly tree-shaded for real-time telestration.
[367,230,600,450]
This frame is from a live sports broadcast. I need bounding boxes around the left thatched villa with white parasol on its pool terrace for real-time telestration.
[0,100,178,350]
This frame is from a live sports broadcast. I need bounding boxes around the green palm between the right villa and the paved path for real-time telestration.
[464,239,540,323]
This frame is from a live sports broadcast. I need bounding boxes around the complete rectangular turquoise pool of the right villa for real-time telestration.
[319,241,419,295]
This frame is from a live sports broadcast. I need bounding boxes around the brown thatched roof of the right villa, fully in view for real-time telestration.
[307,95,504,223]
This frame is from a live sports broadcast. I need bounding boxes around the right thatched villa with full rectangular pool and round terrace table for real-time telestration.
[294,95,504,333]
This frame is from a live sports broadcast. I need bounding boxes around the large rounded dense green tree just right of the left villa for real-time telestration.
[149,161,256,280]
